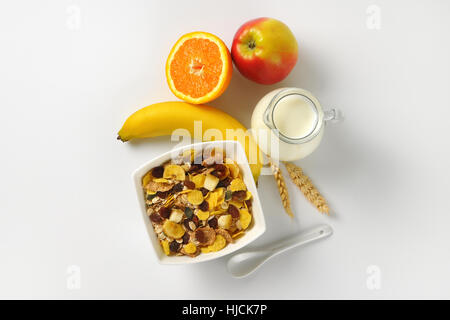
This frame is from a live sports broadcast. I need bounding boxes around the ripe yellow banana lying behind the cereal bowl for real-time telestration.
[117,101,262,182]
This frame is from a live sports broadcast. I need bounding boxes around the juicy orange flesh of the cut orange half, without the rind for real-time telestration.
[170,38,223,98]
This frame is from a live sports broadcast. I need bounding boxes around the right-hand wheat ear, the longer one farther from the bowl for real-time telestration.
[284,162,330,214]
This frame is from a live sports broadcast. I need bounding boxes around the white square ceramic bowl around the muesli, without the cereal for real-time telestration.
[133,140,266,264]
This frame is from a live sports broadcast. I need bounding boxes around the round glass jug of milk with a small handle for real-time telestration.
[251,88,339,161]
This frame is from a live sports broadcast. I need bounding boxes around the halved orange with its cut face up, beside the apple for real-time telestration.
[166,32,233,104]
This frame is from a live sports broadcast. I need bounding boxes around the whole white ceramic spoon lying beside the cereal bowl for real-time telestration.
[227,225,333,278]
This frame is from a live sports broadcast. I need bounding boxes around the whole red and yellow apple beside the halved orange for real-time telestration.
[231,18,298,84]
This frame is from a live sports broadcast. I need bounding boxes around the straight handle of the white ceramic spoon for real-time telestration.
[267,224,333,256]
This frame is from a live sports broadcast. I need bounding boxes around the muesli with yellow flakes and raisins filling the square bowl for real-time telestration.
[142,148,254,257]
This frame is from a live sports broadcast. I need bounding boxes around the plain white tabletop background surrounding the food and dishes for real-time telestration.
[0,0,450,299]
